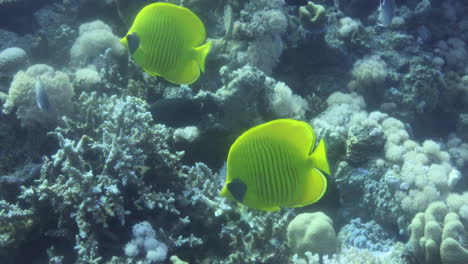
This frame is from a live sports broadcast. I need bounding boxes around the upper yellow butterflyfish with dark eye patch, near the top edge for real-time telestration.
[120,2,211,84]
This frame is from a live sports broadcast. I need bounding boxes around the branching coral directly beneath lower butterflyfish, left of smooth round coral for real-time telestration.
[183,163,294,264]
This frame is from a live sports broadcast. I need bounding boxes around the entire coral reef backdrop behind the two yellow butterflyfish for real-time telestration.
[0,0,468,264]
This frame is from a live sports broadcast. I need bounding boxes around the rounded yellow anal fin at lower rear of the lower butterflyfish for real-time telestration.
[291,169,327,207]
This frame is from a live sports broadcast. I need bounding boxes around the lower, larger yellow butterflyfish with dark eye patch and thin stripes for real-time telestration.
[220,119,330,211]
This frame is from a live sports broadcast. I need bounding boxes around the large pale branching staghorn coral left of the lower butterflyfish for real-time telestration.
[21,93,185,263]
